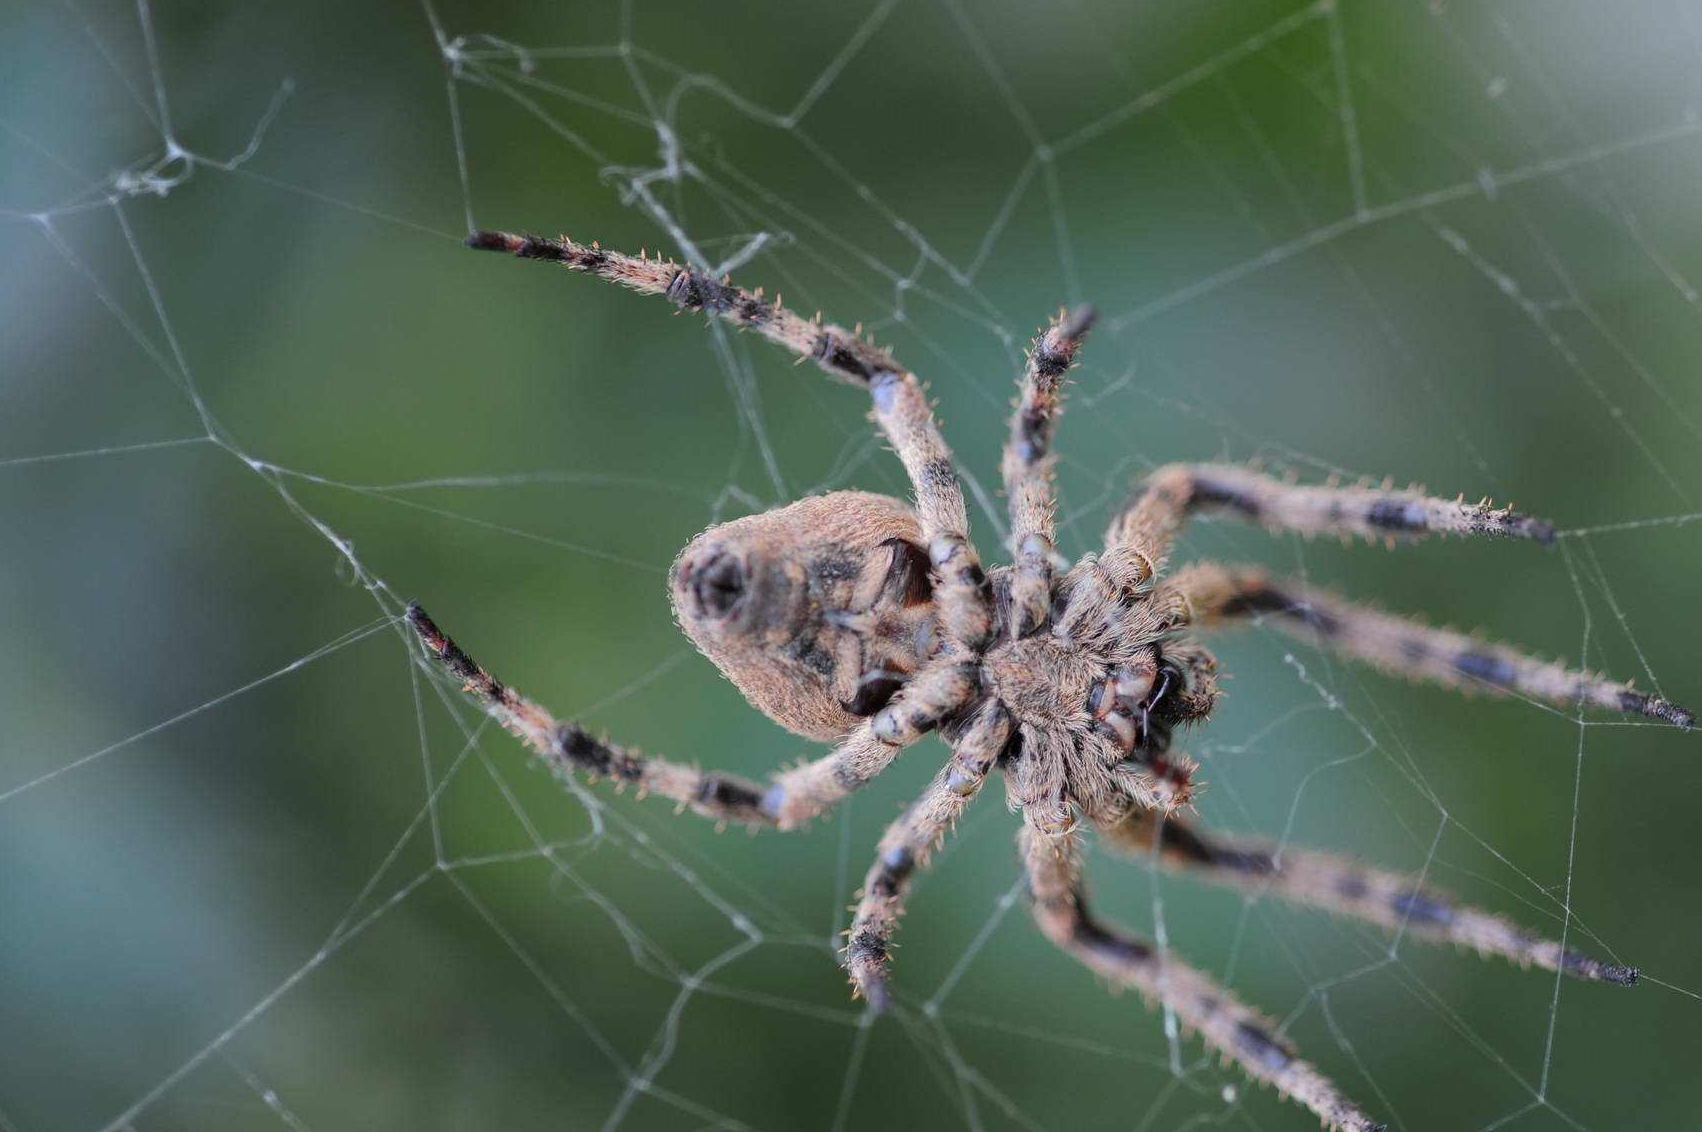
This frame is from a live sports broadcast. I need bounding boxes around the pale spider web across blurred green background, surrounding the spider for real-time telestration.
[0,0,1702,1132]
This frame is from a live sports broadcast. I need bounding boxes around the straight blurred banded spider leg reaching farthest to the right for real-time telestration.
[1156,562,1695,730]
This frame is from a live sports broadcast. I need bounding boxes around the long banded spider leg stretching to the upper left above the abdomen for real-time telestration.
[466,232,992,649]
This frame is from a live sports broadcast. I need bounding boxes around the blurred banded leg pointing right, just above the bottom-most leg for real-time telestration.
[1101,810,1637,987]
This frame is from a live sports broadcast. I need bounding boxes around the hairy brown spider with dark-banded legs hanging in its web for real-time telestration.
[407,232,1693,1132]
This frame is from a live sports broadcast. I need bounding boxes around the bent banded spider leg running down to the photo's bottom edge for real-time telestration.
[1018,826,1385,1132]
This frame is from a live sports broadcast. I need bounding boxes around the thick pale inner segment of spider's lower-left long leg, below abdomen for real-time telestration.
[762,659,980,829]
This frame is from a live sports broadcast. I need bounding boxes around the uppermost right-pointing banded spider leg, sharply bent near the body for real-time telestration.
[1105,463,1554,584]
